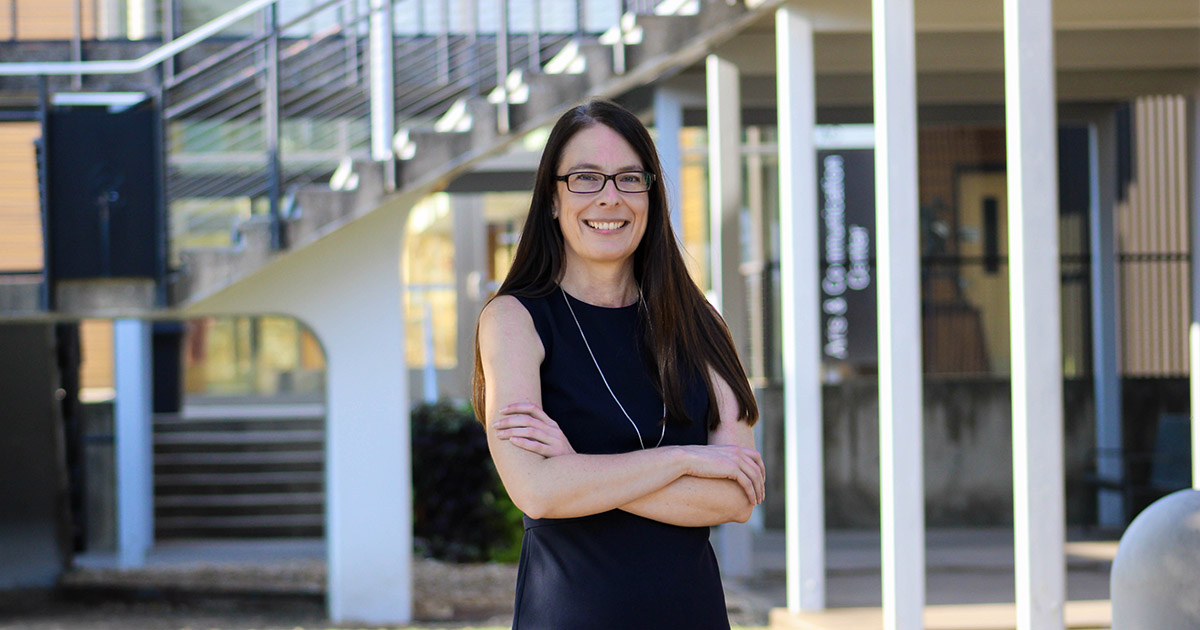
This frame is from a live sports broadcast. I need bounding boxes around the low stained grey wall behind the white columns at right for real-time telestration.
[757,378,1096,528]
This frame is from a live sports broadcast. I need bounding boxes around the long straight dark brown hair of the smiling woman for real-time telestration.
[472,100,758,431]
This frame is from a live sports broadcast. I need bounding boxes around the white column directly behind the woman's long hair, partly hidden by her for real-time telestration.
[706,55,754,576]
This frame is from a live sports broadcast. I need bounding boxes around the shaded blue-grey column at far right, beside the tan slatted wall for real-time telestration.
[1087,113,1126,529]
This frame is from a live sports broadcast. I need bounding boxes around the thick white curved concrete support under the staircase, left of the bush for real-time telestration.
[185,206,413,625]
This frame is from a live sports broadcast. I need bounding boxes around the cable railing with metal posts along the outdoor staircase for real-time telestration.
[0,0,676,274]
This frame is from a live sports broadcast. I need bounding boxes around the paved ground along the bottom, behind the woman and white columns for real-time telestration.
[0,529,1116,630]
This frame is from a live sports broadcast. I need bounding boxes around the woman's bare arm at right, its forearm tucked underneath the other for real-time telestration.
[620,370,766,527]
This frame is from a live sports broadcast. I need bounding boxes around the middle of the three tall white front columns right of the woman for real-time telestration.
[871,0,925,630]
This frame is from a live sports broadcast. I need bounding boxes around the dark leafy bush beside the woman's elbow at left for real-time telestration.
[412,401,523,562]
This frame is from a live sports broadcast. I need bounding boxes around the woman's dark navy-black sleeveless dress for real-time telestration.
[512,289,730,630]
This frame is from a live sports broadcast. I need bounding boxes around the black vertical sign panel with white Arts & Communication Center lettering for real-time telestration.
[817,149,877,364]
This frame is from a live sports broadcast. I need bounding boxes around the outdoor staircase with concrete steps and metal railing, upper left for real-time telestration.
[0,0,780,307]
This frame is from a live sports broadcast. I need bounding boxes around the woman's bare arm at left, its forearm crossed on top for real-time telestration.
[479,296,745,518]
